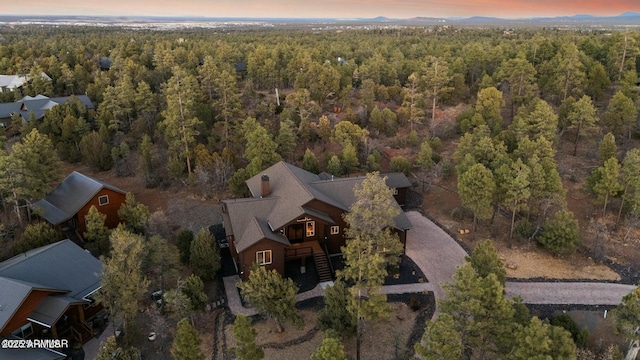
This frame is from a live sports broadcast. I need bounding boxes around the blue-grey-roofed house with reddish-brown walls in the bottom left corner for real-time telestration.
[0,240,106,359]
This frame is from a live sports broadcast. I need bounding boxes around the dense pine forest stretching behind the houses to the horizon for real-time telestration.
[0,26,640,358]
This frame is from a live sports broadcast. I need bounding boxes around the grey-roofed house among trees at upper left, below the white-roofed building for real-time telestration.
[0,95,95,128]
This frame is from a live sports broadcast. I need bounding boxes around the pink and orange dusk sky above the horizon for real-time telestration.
[5,0,640,18]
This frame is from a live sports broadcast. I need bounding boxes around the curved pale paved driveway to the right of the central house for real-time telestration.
[406,211,635,305]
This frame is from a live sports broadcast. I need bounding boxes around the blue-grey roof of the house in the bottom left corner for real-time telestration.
[0,240,102,329]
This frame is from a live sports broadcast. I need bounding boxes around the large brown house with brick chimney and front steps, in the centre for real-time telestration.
[222,161,411,282]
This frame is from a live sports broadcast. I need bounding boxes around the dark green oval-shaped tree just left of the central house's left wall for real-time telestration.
[189,228,220,280]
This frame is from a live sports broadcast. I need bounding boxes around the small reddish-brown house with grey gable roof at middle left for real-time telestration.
[33,171,126,237]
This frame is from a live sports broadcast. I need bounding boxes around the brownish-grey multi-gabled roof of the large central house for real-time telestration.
[223,161,412,252]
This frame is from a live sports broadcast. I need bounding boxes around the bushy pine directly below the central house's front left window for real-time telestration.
[238,264,302,332]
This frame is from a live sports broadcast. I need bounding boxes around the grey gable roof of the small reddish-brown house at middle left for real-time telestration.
[33,171,126,225]
